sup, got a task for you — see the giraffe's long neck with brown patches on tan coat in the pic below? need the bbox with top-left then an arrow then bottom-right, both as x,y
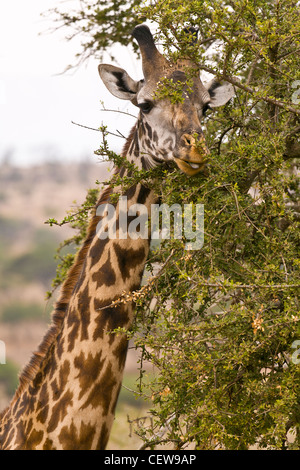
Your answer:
0,125 -> 156,450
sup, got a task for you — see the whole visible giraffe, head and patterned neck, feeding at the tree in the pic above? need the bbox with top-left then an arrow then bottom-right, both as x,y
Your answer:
0,24 -> 232,450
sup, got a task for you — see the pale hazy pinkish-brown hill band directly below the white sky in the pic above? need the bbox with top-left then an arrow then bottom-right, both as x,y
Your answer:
0,161 -> 109,227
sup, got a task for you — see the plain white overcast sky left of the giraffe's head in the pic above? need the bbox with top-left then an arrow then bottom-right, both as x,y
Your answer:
0,0 -> 142,166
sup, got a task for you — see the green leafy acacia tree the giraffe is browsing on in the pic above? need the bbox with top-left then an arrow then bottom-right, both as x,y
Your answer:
48,0 -> 300,449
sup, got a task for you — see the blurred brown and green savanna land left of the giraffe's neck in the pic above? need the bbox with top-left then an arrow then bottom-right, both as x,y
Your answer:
0,161 -> 110,402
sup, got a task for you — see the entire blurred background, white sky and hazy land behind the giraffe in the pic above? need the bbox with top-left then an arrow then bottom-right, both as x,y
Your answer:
0,0 -> 147,449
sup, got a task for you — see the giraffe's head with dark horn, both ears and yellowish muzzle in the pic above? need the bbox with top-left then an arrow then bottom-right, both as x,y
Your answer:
99,25 -> 234,175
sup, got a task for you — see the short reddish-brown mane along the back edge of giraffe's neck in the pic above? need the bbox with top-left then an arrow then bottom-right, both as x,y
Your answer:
0,126 -> 136,418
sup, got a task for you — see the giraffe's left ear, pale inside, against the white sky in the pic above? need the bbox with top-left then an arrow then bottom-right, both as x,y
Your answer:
98,64 -> 139,101
